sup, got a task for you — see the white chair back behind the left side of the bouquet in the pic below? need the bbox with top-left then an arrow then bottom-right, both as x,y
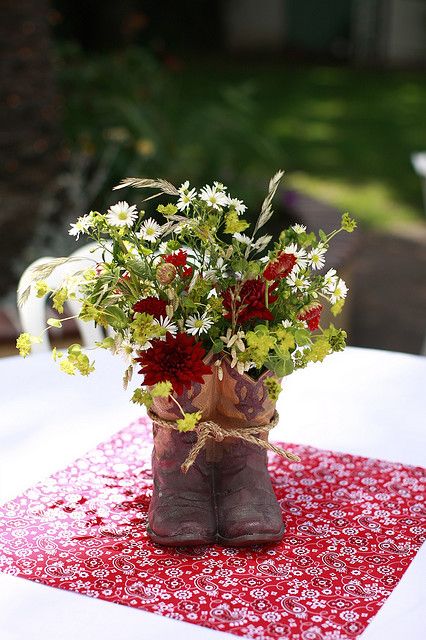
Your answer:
18,242 -> 112,353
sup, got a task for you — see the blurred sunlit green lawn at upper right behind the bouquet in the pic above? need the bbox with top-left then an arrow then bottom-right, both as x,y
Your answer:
177,63 -> 426,227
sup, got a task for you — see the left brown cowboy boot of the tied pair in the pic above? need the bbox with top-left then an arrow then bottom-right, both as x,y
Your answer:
147,376 -> 216,546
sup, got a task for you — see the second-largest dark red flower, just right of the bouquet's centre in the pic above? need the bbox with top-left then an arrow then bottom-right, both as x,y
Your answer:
223,278 -> 277,324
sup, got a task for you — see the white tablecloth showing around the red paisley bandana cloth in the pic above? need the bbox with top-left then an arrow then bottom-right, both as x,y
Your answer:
0,348 -> 426,640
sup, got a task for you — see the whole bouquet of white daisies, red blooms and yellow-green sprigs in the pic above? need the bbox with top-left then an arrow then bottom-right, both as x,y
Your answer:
17,171 -> 356,431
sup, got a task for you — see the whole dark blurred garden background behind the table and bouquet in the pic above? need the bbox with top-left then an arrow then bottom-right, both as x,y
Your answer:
0,0 -> 426,354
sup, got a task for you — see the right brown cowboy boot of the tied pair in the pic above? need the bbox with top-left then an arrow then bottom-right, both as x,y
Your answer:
214,360 -> 285,546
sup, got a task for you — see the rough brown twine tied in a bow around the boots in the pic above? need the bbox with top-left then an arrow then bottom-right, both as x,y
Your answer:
148,409 -> 300,473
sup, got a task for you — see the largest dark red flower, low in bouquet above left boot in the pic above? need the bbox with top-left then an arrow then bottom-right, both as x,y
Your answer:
136,332 -> 212,395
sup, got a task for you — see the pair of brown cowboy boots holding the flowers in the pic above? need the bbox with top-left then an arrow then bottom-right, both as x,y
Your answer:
148,361 -> 284,546
